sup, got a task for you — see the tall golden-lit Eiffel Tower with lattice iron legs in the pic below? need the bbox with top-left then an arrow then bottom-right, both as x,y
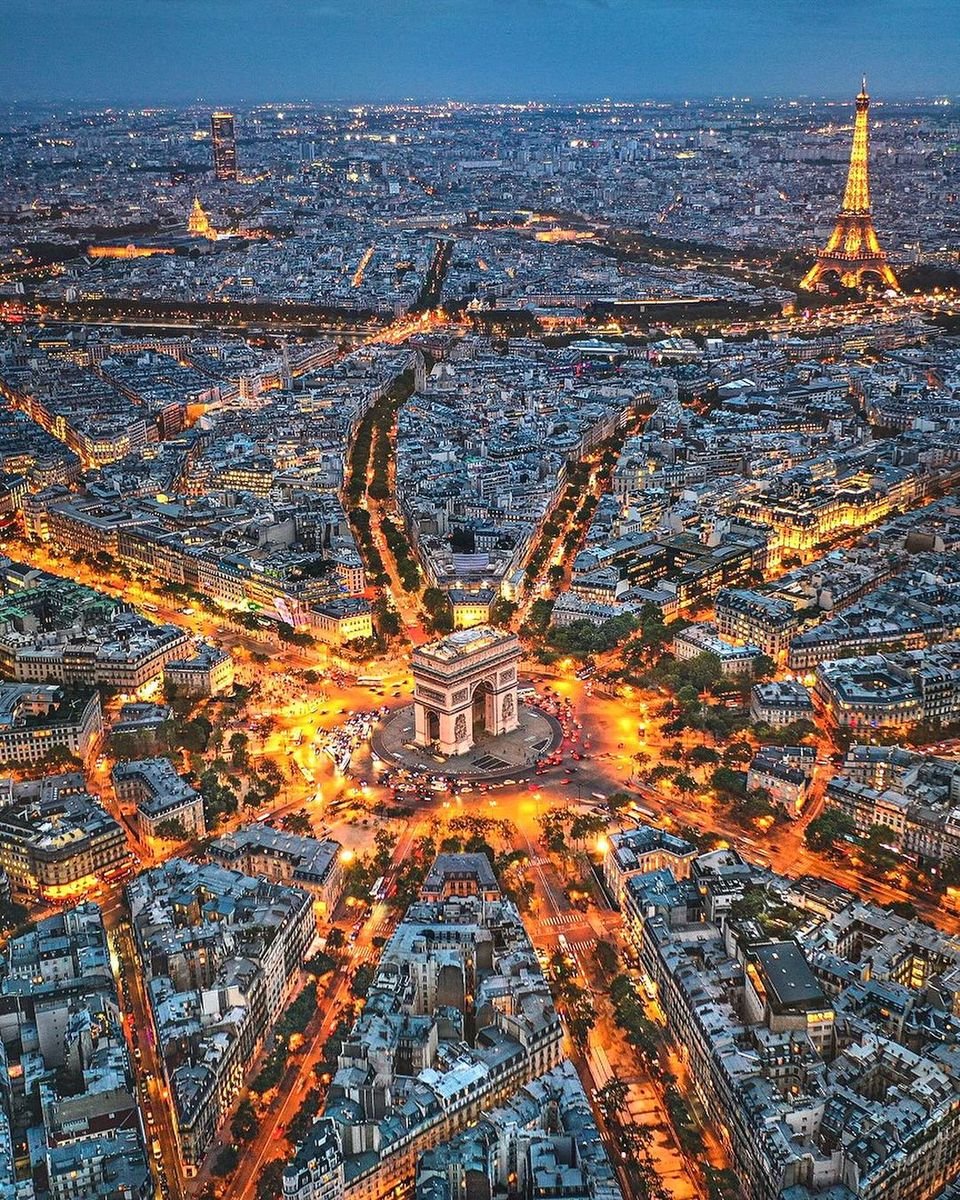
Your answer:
800,78 -> 900,292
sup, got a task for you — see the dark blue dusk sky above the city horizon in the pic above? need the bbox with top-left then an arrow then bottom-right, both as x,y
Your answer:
0,0 -> 960,103
